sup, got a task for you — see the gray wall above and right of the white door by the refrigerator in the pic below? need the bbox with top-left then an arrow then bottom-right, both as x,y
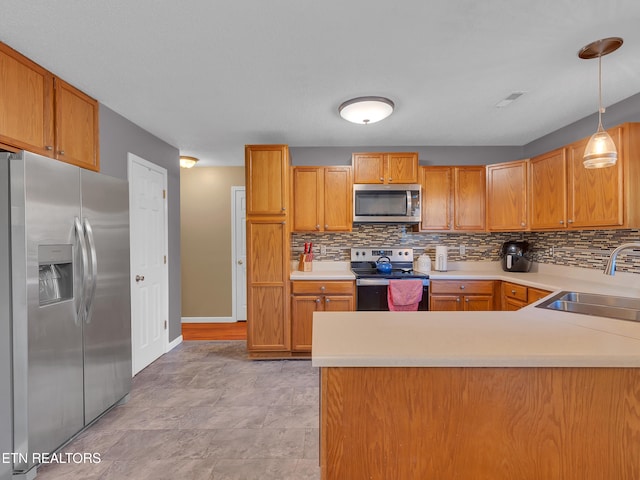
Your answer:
100,104 -> 182,341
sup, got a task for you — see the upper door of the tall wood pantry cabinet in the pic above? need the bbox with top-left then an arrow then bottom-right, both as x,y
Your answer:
245,145 -> 289,216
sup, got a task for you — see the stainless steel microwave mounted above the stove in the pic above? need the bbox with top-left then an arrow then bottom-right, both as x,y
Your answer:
353,184 -> 421,223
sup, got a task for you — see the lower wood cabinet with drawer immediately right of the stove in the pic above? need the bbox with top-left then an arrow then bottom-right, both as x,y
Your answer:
429,280 -> 500,312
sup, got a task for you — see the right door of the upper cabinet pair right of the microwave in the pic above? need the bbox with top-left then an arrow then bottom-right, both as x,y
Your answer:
453,167 -> 486,230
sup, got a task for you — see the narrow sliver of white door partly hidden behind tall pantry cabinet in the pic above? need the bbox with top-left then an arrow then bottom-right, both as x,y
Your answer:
231,187 -> 247,321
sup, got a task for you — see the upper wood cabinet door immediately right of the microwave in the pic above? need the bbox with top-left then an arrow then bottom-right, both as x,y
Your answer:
420,167 -> 452,230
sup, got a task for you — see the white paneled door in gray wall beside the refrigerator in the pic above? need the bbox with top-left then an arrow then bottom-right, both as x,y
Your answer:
129,153 -> 169,375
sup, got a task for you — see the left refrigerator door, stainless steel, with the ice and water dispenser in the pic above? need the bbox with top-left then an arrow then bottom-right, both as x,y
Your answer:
9,152 -> 84,471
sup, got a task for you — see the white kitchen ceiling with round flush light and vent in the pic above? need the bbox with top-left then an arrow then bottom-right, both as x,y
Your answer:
0,0 -> 640,166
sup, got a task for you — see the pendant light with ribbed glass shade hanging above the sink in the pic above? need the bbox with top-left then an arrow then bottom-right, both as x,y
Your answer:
578,37 -> 622,168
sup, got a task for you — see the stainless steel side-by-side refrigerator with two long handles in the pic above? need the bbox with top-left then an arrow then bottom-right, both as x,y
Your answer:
9,152 -> 131,478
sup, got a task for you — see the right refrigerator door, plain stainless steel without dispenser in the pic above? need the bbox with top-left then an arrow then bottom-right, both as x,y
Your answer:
81,170 -> 131,424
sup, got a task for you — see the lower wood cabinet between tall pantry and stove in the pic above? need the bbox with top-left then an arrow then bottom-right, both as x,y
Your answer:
291,280 -> 355,352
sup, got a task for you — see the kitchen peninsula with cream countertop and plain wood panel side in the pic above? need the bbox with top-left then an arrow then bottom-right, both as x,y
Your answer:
313,278 -> 640,480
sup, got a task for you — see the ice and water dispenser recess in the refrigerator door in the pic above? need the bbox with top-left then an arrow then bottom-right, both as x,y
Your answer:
38,245 -> 73,306
